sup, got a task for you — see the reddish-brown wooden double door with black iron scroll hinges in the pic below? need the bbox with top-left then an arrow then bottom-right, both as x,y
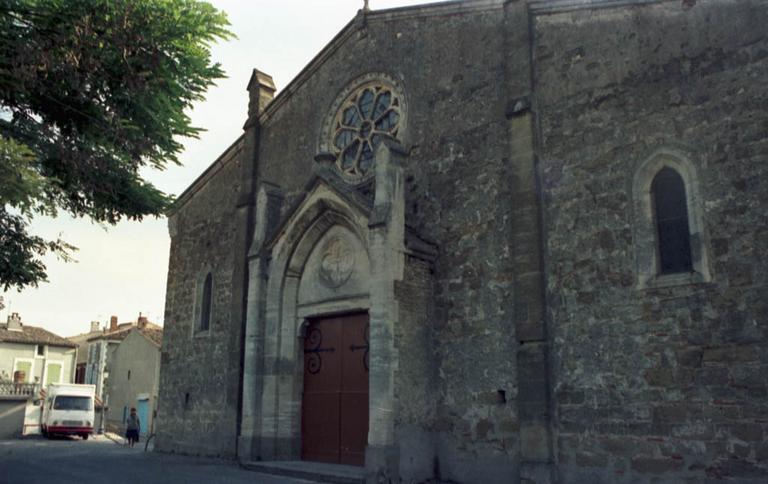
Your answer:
301,313 -> 369,466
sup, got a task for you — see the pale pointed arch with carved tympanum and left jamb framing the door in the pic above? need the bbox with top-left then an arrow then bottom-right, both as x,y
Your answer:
261,195 -> 371,459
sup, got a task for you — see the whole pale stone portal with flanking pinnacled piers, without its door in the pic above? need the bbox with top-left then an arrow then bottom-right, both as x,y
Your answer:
238,144 -> 433,478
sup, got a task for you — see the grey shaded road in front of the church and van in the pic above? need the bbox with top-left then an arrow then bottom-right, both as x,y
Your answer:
0,436 -> 316,484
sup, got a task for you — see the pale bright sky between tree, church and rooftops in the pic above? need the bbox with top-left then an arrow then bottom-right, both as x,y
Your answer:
0,0 -> 426,336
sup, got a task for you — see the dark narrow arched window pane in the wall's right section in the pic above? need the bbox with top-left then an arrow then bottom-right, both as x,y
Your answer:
651,167 -> 693,274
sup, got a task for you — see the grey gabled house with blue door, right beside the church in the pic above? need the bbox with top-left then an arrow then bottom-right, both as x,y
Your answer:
105,320 -> 163,434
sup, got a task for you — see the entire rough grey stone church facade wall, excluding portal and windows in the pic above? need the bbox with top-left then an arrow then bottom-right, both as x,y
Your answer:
158,0 -> 768,482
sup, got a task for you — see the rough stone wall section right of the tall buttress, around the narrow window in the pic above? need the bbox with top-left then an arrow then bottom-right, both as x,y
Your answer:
534,0 -> 768,483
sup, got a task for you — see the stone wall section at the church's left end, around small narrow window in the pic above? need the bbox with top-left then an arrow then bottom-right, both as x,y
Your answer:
157,143 -> 248,457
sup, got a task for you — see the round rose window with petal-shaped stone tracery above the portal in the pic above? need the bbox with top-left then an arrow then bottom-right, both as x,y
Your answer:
333,82 -> 402,178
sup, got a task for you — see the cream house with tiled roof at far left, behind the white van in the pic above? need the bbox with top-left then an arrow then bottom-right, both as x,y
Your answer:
0,313 -> 77,439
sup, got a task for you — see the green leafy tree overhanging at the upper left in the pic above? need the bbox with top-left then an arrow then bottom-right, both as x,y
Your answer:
0,0 -> 232,290
